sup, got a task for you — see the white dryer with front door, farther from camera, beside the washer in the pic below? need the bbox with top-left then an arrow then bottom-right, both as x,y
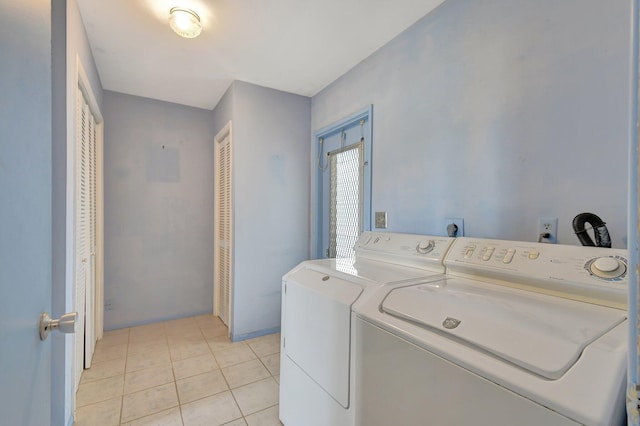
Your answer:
280,232 -> 453,426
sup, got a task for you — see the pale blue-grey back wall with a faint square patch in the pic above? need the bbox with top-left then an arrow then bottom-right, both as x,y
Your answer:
103,91 -> 214,330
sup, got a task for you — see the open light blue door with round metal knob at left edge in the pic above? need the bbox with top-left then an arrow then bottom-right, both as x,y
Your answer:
0,0 -> 52,425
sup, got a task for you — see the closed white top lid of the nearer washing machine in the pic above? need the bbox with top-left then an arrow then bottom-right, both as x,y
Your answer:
382,278 -> 626,379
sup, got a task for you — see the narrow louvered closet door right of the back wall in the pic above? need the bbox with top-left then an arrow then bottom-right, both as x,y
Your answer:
215,135 -> 233,326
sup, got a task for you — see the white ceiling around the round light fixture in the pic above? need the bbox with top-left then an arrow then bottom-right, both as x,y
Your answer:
78,0 -> 444,109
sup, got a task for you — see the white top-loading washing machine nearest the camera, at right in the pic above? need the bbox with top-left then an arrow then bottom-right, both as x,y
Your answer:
354,237 -> 627,426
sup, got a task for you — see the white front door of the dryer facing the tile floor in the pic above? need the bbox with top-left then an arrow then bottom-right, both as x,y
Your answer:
282,268 -> 362,408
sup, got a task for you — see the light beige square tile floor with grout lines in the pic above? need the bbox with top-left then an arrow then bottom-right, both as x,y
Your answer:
75,315 -> 281,426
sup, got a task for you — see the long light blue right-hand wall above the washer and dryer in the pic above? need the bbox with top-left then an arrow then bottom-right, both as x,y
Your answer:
312,0 -> 631,247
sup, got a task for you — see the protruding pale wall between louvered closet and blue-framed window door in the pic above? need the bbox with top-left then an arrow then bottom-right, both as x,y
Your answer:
213,81 -> 311,340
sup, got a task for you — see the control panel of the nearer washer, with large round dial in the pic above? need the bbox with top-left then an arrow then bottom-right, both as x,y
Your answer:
445,237 -> 628,308
